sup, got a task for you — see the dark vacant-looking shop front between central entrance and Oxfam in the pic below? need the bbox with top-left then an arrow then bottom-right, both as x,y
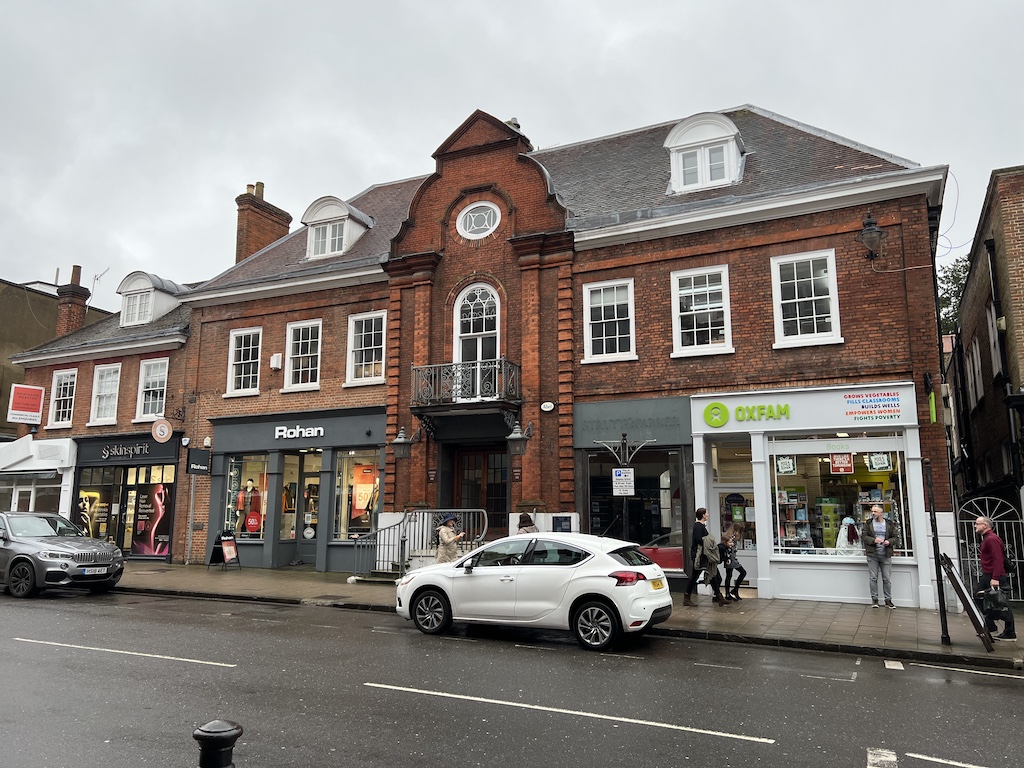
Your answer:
573,397 -> 693,558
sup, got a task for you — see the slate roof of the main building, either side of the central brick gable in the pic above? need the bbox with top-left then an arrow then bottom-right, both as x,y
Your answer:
179,104 -> 933,302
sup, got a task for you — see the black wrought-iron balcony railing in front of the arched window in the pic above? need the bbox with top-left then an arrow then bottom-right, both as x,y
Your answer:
412,357 -> 522,407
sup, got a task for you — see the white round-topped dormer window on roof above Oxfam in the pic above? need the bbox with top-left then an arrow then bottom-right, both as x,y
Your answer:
665,113 -> 743,195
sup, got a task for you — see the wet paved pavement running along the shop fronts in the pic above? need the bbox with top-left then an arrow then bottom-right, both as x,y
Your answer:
118,560 -> 1024,670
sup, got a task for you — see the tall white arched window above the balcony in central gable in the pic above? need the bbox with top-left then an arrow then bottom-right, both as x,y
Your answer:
454,284 -> 500,400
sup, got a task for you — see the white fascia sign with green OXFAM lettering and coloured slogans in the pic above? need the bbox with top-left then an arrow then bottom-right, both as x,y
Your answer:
690,382 -> 918,432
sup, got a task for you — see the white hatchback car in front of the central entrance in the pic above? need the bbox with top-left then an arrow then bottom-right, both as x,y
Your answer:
397,534 -> 672,650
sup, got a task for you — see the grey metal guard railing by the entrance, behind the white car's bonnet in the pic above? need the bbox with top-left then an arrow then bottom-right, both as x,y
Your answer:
352,509 -> 487,579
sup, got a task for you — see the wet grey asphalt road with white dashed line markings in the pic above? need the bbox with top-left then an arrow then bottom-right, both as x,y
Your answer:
0,592 -> 1024,768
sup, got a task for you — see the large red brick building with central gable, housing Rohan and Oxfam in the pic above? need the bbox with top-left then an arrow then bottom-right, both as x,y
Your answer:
8,105 -> 951,605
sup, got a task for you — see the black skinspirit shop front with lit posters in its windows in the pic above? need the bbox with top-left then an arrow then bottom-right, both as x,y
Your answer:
73,433 -> 181,559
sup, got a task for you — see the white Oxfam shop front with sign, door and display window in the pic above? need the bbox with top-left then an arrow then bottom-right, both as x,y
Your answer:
690,382 -> 952,608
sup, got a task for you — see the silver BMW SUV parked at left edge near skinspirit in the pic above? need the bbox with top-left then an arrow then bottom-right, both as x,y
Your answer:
0,512 -> 125,597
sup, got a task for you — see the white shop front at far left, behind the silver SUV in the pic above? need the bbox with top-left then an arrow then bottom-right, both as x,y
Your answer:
0,435 -> 78,522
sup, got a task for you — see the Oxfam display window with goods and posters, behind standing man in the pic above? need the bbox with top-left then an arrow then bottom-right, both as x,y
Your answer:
771,447 -> 913,557
